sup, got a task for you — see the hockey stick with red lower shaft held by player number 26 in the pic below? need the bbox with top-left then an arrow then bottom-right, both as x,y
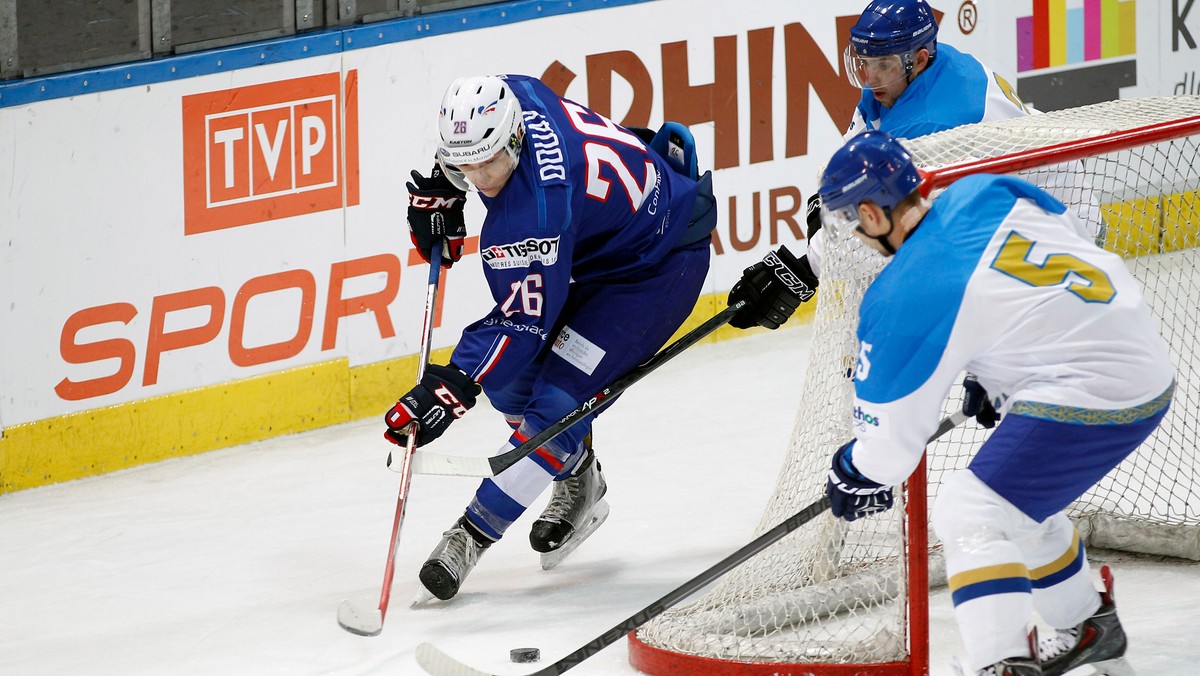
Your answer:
337,243 -> 442,636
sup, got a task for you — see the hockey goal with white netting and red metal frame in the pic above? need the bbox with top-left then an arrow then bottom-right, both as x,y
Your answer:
630,96 -> 1200,675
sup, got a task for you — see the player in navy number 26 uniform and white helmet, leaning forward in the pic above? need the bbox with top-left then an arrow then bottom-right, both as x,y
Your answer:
386,76 -> 715,599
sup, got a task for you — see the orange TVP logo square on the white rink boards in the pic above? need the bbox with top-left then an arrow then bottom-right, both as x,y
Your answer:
182,71 -> 359,234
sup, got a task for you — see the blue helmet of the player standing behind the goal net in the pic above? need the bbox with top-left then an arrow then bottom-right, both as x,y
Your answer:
850,0 -> 937,56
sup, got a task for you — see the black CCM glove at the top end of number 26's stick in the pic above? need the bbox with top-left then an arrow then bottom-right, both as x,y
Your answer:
406,163 -> 467,268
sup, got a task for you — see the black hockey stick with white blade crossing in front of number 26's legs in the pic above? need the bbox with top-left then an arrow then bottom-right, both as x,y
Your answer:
413,300 -> 746,477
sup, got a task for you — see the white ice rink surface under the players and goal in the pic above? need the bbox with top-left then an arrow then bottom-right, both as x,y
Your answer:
0,327 -> 1200,676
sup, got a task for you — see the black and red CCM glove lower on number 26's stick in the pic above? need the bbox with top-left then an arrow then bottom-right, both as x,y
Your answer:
383,364 -> 482,447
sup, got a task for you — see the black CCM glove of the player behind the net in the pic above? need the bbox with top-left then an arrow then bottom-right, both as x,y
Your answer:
730,246 -> 817,329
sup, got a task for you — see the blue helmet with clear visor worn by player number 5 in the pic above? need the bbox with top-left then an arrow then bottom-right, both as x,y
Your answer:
817,130 -> 920,239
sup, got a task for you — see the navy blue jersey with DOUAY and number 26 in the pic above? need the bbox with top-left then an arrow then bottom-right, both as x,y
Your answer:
451,76 -> 698,387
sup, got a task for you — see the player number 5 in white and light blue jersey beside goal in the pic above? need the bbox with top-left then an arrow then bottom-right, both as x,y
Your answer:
820,131 -> 1175,676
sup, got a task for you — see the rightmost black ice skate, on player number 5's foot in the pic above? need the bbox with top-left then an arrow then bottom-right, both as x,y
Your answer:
1038,566 -> 1134,676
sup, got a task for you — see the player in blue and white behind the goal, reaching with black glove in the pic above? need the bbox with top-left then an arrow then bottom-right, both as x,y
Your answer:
730,0 -> 1030,328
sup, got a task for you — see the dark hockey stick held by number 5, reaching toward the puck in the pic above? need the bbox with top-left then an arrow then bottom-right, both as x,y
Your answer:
416,411 -> 967,676
